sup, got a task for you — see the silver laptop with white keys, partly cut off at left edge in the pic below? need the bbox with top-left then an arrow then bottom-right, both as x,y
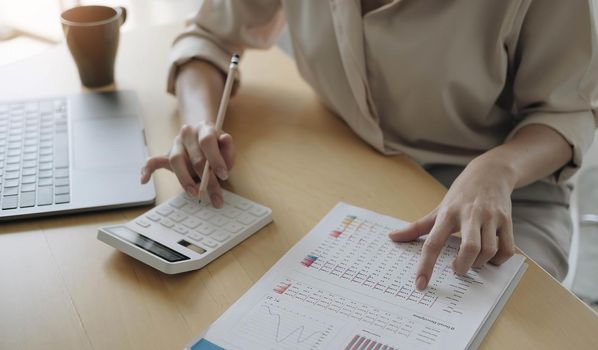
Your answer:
0,91 -> 156,220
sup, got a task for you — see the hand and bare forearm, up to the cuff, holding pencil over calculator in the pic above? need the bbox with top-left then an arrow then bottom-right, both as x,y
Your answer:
141,60 -> 235,208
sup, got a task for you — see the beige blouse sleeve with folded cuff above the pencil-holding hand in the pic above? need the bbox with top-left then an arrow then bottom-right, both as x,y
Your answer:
167,0 -> 285,94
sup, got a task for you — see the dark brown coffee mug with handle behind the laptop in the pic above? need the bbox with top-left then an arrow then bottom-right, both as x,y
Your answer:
60,6 -> 127,87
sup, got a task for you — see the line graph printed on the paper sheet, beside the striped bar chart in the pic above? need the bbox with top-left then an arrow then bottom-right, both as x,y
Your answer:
237,296 -> 334,350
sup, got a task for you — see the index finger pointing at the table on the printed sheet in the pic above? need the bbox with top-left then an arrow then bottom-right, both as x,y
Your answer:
415,216 -> 452,290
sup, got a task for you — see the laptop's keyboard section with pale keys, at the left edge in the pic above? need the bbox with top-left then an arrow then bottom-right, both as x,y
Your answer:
0,99 -> 70,210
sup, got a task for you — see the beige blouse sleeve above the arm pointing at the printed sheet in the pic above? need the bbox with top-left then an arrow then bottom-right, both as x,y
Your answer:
507,0 -> 598,183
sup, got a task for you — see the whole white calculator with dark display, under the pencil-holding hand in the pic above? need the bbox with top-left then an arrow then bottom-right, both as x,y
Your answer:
98,190 -> 272,274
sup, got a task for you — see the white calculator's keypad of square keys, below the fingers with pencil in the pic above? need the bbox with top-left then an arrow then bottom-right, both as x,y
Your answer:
134,191 -> 269,254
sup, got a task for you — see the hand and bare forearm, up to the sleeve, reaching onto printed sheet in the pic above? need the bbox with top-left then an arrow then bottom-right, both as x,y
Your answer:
390,124 -> 573,290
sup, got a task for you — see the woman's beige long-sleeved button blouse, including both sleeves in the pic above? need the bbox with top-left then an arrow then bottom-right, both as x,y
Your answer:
168,0 -> 598,181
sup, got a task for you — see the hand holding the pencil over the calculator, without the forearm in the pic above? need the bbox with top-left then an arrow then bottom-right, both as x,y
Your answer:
141,122 -> 235,208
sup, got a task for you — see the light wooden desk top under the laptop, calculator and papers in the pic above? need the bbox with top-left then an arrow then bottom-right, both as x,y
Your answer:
0,25 -> 598,350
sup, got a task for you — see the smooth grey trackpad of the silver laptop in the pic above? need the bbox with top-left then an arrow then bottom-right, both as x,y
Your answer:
71,116 -> 144,169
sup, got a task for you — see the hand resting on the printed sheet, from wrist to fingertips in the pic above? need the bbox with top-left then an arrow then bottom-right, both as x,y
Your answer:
390,156 -> 515,290
